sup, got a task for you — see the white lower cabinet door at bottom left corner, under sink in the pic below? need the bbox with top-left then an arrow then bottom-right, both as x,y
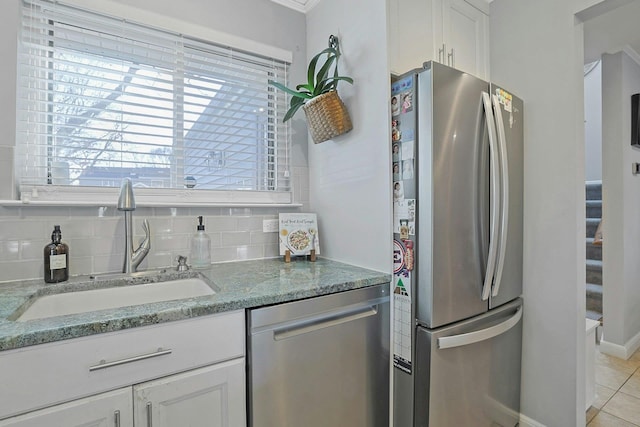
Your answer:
0,387 -> 133,427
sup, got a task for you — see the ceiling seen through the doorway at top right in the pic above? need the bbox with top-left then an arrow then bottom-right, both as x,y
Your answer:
584,0 -> 640,64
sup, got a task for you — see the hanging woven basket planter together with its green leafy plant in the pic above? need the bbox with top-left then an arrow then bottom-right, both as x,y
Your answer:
269,36 -> 353,144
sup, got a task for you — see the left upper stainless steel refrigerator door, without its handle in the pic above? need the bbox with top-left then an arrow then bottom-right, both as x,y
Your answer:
415,63 -> 490,328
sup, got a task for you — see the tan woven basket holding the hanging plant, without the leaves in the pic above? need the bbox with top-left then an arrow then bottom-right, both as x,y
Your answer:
302,90 -> 353,144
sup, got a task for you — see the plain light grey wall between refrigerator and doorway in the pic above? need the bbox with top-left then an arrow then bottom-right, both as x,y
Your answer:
490,0 -> 585,426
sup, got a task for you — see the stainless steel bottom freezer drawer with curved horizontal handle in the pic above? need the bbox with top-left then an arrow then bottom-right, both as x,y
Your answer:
414,299 -> 522,427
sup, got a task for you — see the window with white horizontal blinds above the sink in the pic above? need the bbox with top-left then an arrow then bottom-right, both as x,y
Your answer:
16,0 -> 290,204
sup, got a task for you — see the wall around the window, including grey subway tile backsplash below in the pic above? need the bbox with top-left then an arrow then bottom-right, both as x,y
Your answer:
0,0 -> 309,281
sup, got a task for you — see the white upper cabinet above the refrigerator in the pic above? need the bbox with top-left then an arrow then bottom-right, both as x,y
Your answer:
388,0 -> 489,79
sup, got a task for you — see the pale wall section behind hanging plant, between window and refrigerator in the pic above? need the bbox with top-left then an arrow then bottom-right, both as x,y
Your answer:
307,0 -> 392,272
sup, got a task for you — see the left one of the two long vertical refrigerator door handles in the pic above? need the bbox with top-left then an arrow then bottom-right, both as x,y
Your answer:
482,92 -> 500,301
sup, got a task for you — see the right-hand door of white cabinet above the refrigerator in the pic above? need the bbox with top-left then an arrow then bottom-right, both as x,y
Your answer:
441,0 -> 489,80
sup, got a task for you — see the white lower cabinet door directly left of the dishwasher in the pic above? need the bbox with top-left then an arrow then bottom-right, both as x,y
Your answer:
133,358 -> 246,427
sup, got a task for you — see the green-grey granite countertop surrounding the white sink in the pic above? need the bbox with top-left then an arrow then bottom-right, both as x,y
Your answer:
0,258 -> 391,351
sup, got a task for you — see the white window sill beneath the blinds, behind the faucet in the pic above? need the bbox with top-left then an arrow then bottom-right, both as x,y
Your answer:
0,185 -> 302,208
